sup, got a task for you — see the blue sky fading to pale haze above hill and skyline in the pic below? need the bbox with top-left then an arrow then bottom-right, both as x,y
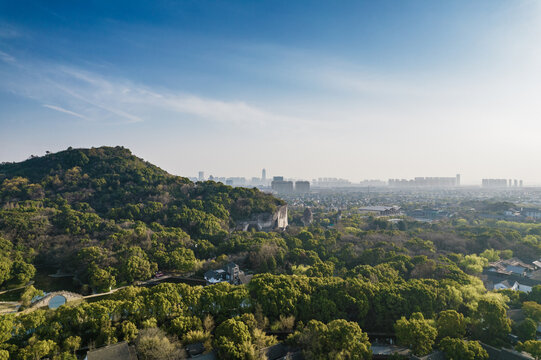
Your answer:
0,0 -> 541,185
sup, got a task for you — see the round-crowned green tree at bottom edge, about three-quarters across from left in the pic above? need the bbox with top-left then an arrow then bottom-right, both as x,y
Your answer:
394,313 -> 438,356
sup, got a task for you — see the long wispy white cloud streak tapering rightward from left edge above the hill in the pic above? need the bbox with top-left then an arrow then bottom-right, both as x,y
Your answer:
0,57 -> 300,125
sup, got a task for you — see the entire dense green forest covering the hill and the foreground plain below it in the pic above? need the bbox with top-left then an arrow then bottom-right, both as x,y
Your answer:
0,147 -> 541,359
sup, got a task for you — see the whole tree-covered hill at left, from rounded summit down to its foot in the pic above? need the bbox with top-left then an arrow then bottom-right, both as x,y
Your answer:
0,147 -> 283,288
